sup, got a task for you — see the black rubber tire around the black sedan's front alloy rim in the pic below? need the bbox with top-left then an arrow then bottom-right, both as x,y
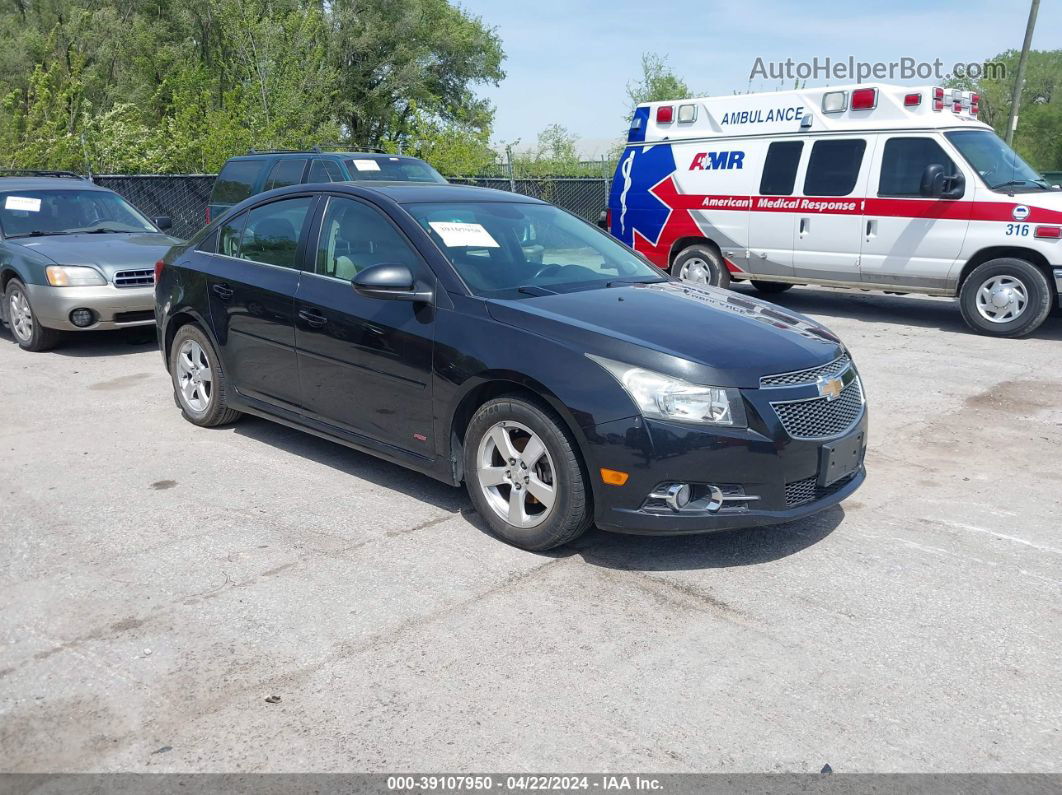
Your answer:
464,396 -> 594,552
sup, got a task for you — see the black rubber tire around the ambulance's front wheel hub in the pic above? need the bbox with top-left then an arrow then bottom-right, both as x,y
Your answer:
959,257 -> 1055,338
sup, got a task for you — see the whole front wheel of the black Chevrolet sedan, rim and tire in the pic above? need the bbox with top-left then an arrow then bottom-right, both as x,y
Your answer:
464,397 -> 592,551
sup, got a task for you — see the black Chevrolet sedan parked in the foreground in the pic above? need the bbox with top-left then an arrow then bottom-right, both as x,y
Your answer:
156,183 -> 867,550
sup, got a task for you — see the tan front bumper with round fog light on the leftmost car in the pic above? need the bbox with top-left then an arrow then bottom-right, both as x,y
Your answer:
25,284 -> 155,331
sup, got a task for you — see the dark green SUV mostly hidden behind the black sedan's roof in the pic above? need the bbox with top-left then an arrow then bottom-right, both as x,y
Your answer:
206,148 -> 446,224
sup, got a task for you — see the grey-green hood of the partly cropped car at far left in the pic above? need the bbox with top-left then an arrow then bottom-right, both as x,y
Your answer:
7,232 -> 181,278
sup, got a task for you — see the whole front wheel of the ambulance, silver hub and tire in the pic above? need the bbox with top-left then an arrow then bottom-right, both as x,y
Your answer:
959,257 -> 1052,338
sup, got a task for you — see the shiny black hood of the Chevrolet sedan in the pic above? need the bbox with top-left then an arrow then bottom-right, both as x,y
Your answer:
487,281 -> 844,388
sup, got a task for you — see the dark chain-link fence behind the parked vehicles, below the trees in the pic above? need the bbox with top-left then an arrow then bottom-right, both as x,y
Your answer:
93,174 -> 611,240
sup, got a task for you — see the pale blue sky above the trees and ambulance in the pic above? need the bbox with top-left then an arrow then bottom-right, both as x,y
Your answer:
458,0 -> 1062,158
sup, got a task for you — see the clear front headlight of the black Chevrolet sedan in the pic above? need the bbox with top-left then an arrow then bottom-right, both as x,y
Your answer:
586,353 -> 748,428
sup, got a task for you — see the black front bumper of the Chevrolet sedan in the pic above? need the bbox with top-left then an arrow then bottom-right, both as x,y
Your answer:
586,390 -> 868,535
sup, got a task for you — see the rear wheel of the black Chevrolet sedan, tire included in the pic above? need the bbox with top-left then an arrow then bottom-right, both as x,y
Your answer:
170,325 -> 240,428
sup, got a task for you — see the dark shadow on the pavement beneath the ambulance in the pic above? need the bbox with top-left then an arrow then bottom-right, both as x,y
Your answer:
732,282 -> 1062,340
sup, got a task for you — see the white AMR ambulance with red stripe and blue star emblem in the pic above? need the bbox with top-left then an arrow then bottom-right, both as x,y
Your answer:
605,84 -> 1062,336
